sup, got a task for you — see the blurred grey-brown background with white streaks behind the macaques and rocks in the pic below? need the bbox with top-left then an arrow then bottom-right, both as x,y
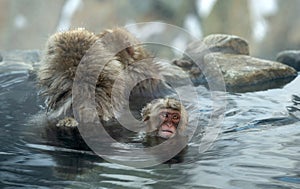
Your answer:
0,0 -> 300,59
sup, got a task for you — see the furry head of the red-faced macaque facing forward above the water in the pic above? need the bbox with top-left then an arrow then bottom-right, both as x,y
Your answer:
142,98 -> 188,139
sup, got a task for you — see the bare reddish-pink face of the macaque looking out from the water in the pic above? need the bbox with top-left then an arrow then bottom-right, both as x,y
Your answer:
158,109 -> 180,139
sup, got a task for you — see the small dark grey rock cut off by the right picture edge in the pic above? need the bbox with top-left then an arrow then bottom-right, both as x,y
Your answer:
276,50 -> 300,71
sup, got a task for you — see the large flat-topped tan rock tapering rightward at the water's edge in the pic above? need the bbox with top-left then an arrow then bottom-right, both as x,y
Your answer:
203,53 -> 297,92
